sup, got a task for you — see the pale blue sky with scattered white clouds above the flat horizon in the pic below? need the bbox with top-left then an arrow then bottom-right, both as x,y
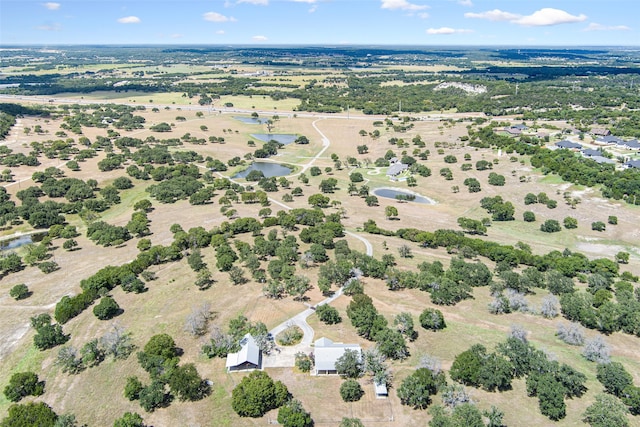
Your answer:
0,0 -> 640,46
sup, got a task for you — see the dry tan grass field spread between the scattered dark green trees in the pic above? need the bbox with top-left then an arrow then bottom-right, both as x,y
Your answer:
0,93 -> 640,427
